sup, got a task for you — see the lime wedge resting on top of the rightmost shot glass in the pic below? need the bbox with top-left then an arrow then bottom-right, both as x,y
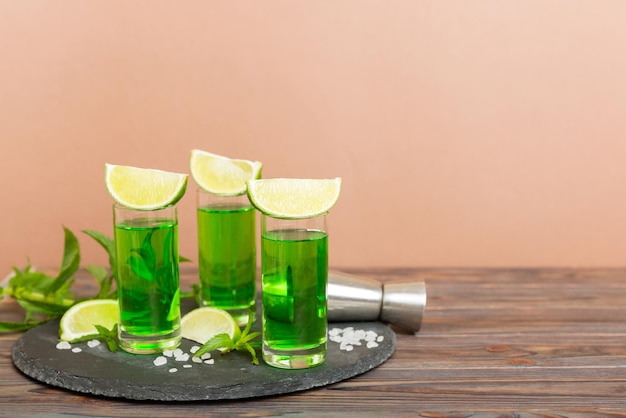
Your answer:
248,177 -> 341,219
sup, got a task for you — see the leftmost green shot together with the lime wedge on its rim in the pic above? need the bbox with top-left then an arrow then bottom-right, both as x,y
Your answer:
105,164 -> 187,354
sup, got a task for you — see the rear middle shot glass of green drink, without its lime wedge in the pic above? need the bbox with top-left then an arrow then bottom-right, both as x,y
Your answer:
197,189 -> 256,326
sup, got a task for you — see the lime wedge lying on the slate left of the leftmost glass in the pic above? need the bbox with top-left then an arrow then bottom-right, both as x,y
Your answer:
59,299 -> 120,341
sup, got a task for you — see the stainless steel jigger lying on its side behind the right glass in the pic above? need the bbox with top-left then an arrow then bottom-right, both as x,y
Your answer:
327,272 -> 426,333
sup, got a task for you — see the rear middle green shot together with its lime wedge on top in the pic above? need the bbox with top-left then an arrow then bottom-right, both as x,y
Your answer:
189,149 -> 263,326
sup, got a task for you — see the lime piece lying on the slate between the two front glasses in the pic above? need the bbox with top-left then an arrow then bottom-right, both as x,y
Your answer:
180,306 -> 241,344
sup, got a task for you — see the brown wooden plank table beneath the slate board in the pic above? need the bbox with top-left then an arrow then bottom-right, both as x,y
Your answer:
0,269 -> 626,417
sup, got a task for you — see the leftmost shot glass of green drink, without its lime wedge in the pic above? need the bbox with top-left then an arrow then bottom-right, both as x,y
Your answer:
113,204 -> 181,354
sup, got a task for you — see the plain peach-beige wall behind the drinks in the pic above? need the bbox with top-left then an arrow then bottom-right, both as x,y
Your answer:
0,0 -> 626,275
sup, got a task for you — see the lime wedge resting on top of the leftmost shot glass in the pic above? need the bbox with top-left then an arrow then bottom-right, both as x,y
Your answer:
105,164 -> 187,210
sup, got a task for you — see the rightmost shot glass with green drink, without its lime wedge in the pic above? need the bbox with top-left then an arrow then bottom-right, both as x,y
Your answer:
261,215 -> 328,369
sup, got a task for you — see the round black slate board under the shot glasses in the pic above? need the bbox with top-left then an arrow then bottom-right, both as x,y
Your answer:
12,321 -> 396,401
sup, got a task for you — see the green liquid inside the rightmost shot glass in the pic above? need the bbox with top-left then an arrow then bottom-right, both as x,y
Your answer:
262,230 -> 328,351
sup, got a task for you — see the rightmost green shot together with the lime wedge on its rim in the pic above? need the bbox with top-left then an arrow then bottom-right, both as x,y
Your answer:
248,178 -> 341,369
